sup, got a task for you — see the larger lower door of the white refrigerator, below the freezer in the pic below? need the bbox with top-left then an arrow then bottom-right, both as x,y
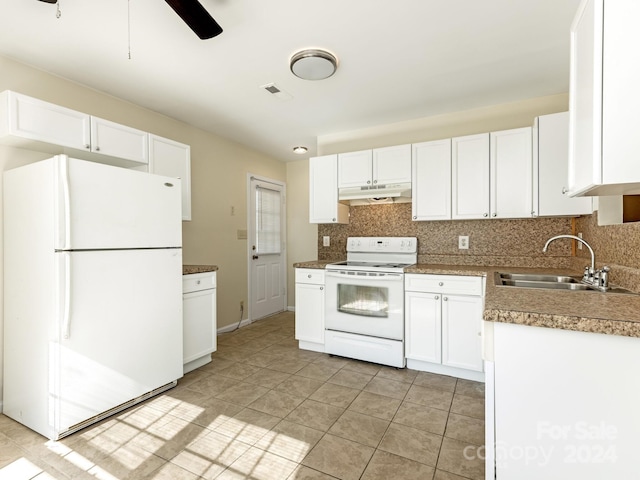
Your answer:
49,249 -> 182,437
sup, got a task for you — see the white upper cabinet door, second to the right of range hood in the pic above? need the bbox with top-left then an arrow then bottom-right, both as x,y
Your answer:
451,133 -> 489,220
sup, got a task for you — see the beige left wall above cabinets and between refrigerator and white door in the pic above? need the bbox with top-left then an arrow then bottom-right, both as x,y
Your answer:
0,57 -> 287,398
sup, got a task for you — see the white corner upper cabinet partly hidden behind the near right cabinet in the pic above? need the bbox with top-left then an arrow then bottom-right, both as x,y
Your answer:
533,112 -> 593,216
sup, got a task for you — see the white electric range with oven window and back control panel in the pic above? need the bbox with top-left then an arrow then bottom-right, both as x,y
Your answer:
325,237 -> 418,368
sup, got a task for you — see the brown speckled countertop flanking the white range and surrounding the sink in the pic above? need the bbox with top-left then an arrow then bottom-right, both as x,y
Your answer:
294,260 -> 640,337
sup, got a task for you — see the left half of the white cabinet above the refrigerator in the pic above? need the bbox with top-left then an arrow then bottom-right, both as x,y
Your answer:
0,90 -> 91,153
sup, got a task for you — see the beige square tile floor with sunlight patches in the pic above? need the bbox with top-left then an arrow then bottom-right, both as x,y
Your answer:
0,312 -> 484,480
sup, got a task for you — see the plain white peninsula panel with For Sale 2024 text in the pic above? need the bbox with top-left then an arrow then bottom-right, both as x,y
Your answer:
486,318 -> 640,480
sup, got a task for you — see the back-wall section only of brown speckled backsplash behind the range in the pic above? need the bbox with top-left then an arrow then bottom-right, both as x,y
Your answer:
318,203 -> 573,268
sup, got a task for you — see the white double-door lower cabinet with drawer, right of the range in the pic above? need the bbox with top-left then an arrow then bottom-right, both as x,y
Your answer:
405,274 -> 484,381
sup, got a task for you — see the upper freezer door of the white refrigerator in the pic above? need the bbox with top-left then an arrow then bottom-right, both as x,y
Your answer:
51,155 -> 182,250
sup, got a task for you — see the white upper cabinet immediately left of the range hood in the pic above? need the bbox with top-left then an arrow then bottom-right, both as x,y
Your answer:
309,155 -> 349,227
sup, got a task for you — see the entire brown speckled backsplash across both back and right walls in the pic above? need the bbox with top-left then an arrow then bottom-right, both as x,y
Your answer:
318,203 -> 640,292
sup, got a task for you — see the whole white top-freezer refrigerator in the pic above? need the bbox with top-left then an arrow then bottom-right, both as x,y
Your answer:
3,155 -> 182,440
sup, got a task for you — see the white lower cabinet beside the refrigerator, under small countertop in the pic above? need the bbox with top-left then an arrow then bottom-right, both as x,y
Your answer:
182,272 -> 217,373
